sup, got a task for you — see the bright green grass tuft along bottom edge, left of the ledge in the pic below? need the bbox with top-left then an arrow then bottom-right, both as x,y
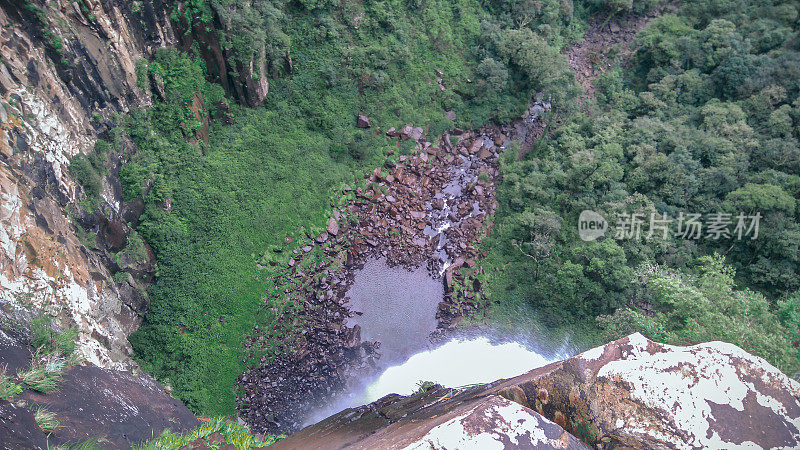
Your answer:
133,417 -> 285,450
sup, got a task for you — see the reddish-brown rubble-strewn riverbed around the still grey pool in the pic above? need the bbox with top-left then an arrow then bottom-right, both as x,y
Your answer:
237,121 -> 520,433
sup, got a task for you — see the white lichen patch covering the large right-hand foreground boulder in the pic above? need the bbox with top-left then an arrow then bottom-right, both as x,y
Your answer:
597,334 -> 800,448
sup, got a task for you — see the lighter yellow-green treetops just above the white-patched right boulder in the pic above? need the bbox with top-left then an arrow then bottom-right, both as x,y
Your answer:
598,255 -> 800,374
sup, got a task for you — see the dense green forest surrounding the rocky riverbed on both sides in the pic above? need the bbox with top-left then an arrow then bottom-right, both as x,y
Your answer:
72,0 -> 800,414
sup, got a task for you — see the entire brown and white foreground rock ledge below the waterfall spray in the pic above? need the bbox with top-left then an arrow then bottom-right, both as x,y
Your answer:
274,333 -> 800,449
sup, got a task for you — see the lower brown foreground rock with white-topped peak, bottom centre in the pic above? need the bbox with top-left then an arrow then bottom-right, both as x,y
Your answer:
270,386 -> 588,450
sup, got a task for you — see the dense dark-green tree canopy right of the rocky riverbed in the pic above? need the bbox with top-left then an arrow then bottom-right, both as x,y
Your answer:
484,0 -> 800,375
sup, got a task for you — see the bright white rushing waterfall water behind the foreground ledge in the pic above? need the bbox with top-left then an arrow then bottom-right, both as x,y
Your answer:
306,337 -> 568,425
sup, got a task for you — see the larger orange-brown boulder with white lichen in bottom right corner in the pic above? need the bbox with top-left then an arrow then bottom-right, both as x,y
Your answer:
492,333 -> 800,448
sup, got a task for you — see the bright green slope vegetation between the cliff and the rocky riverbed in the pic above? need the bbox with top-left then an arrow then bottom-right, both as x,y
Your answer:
125,0 -> 583,414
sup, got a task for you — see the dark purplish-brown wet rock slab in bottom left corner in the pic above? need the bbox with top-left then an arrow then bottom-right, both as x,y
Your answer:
0,334 -> 197,449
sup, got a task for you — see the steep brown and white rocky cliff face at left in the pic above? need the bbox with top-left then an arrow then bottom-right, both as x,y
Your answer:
0,0 -> 268,368
